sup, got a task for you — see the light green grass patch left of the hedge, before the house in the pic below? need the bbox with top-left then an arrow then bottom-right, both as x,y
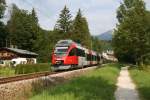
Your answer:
0,67 -> 15,77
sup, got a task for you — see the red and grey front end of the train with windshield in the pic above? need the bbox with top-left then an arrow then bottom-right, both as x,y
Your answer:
52,40 -> 76,71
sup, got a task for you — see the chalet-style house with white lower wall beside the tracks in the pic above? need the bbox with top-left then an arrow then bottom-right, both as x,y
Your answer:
0,48 -> 38,66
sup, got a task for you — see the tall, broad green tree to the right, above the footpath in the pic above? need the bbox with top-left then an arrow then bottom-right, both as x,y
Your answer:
113,0 -> 150,64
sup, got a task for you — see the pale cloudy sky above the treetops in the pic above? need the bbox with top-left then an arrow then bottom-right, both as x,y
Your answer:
6,0 -> 150,35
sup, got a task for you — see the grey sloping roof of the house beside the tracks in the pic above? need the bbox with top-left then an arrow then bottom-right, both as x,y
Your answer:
0,48 -> 38,56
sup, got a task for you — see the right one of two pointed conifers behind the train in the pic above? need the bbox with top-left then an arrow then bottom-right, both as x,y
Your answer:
72,9 -> 91,48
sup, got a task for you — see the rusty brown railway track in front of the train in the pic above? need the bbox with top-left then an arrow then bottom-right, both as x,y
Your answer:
0,72 -> 56,85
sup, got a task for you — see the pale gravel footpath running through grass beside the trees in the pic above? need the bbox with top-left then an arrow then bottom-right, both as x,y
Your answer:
115,67 -> 139,100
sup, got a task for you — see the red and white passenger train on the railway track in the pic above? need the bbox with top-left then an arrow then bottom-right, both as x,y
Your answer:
52,40 -> 102,71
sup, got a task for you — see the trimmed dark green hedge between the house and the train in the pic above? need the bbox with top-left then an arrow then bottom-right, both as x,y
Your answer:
15,63 -> 51,74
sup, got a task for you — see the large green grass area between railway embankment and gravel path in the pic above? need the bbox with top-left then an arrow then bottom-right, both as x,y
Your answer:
30,64 -> 120,100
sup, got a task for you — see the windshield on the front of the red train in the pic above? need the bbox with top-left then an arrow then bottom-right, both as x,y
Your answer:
54,47 -> 68,56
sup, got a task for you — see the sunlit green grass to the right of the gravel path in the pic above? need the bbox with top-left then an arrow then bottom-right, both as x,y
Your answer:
130,68 -> 150,100
